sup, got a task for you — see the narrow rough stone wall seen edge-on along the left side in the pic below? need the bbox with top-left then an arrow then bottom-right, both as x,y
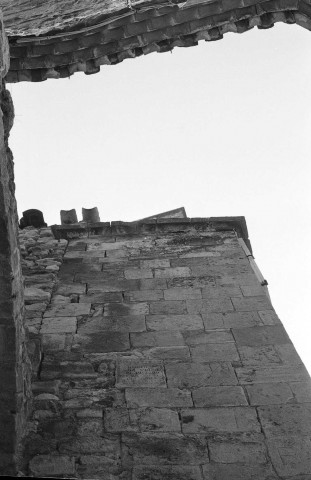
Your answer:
0,10 -> 30,475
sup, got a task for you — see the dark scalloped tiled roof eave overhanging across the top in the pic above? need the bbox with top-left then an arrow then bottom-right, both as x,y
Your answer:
3,0 -> 311,83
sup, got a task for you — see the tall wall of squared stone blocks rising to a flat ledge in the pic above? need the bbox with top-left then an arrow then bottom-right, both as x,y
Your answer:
23,219 -> 311,480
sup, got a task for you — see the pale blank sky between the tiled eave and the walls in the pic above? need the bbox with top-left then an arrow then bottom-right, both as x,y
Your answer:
8,24 -> 311,373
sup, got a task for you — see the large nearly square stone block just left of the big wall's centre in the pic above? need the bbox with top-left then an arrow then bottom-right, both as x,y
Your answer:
116,358 -> 166,388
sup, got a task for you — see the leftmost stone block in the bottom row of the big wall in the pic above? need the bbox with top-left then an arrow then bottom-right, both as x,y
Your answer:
29,455 -> 76,477
